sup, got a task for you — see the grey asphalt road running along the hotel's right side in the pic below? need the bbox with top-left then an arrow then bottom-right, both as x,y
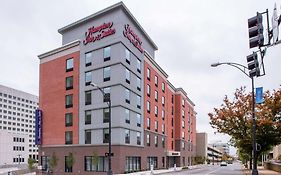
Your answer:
163,163 -> 244,175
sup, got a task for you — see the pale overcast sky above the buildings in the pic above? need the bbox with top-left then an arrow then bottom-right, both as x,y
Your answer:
0,0 -> 281,154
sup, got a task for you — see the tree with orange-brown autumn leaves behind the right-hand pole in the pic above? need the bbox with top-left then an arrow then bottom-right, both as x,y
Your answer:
208,87 -> 281,161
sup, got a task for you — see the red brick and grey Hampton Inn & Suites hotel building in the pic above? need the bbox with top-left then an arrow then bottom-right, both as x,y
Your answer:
38,2 -> 196,174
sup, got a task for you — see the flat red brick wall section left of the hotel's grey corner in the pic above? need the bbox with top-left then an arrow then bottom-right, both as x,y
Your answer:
39,52 -> 80,145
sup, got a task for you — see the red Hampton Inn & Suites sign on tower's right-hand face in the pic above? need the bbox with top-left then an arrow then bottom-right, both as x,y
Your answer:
123,24 -> 144,53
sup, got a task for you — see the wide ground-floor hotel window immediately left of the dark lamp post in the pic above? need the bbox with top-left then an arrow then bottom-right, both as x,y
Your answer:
84,156 -> 108,172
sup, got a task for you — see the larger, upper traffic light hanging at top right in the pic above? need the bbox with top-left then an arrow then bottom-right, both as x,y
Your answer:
248,13 -> 264,48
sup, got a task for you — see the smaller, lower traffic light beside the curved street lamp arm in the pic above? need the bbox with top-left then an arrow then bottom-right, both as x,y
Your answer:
247,52 -> 260,77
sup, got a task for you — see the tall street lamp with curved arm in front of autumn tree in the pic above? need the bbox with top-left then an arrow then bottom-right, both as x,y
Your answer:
211,62 -> 259,175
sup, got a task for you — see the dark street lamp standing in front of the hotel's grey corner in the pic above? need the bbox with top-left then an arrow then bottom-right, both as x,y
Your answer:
90,83 -> 112,175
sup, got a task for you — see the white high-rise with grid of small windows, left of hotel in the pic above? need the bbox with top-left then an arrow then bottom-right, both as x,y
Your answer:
0,85 -> 38,166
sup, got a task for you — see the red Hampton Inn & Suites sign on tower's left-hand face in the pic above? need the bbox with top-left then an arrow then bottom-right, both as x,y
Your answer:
83,22 -> 116,45
